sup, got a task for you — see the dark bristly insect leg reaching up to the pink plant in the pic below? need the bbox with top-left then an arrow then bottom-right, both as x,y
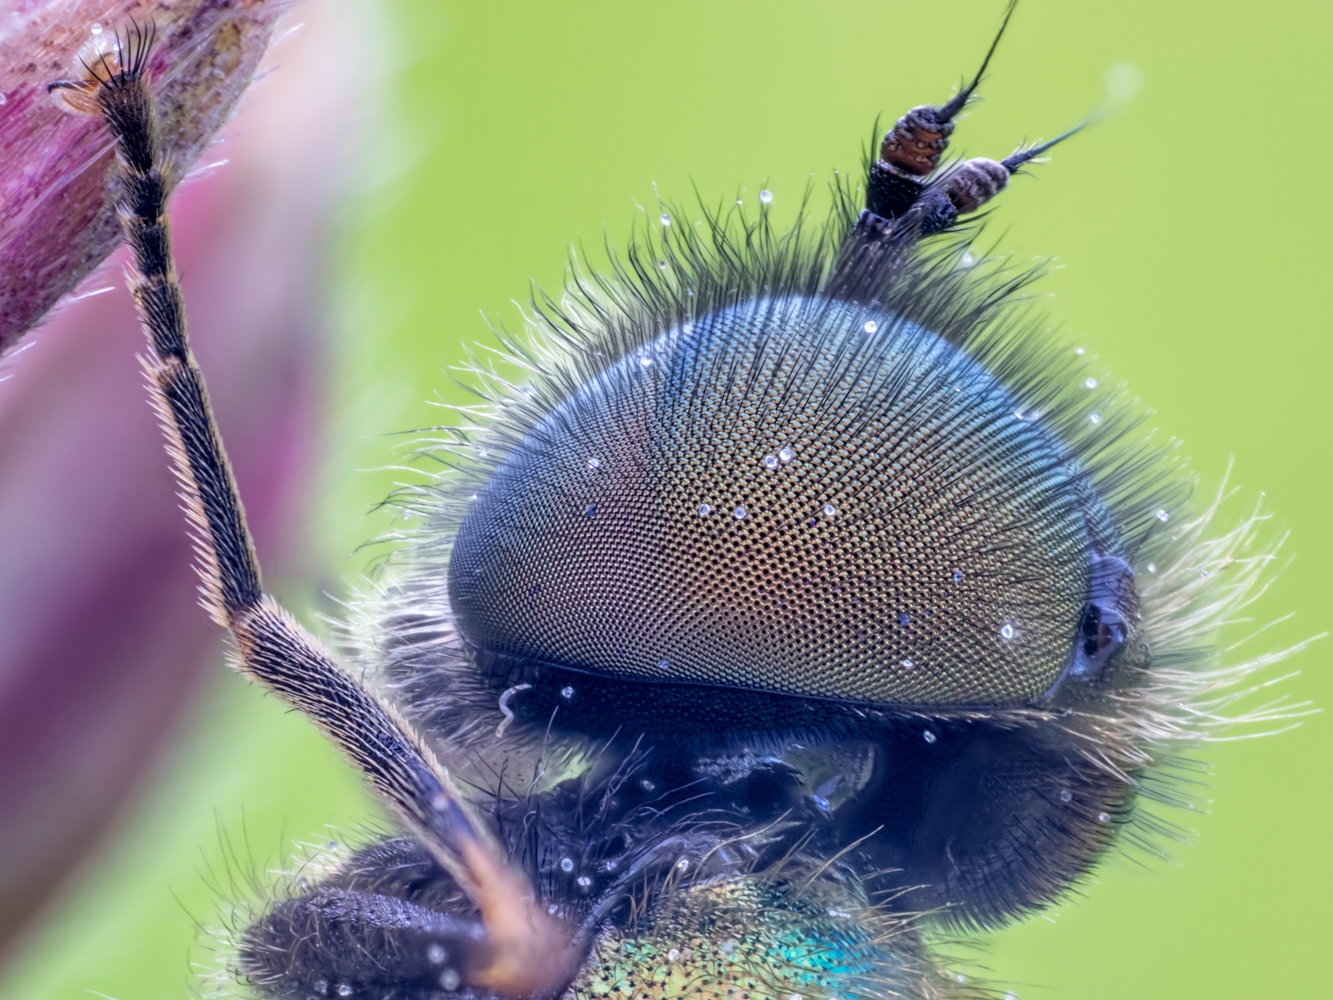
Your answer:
52,24 -> 573,996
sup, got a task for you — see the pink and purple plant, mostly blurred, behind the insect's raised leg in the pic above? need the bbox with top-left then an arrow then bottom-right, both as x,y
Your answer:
0,0 -> 364,948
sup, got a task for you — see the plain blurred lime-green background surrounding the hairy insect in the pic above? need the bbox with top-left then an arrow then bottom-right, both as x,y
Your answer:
0,0 -> 1333,1000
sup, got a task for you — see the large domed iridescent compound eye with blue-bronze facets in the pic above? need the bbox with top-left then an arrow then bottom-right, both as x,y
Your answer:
449,296 -> 1125,705
